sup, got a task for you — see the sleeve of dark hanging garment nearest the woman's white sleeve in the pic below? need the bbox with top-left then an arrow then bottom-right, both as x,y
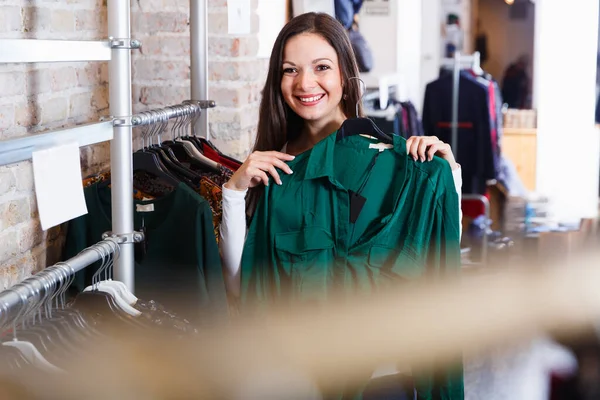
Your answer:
196,202 -> 228,318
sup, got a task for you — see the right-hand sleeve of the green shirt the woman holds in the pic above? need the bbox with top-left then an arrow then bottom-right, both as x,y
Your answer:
413,169 -> 464,400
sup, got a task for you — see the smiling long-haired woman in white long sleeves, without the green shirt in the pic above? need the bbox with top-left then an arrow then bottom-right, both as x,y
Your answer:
220,13 -> 462,298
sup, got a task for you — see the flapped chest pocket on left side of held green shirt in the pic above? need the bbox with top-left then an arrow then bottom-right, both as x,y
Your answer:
275,227 -> 335,297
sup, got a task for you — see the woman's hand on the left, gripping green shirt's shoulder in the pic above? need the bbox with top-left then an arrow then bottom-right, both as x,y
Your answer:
225,151 -> 294,191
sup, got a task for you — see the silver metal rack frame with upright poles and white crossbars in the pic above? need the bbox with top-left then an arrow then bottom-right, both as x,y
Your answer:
0,0 -> 214,293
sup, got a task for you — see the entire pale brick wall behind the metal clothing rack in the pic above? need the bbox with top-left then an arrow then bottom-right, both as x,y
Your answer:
0,0 -> 267,289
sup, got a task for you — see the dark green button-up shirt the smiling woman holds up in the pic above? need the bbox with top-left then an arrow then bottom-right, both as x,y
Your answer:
241,134 -> 463,399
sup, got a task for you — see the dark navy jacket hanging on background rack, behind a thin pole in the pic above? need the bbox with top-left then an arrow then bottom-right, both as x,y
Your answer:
423,71 -> 496,194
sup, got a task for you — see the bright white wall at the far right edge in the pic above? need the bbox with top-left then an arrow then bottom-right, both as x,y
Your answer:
534,0 -> 600,219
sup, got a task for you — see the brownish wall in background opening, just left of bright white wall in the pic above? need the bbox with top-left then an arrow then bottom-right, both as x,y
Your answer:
478,0 -> 535,85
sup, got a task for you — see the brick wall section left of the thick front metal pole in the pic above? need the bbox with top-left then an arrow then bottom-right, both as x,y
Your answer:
0,0 -> 108,289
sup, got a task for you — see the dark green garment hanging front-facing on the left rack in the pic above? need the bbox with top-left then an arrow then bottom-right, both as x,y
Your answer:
63,183 -> 227,323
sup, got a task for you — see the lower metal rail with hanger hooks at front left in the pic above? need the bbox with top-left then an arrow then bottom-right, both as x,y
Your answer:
0,238 -> 119,325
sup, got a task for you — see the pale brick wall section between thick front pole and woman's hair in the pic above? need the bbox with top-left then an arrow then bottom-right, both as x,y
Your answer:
132,0 -> 268,160
